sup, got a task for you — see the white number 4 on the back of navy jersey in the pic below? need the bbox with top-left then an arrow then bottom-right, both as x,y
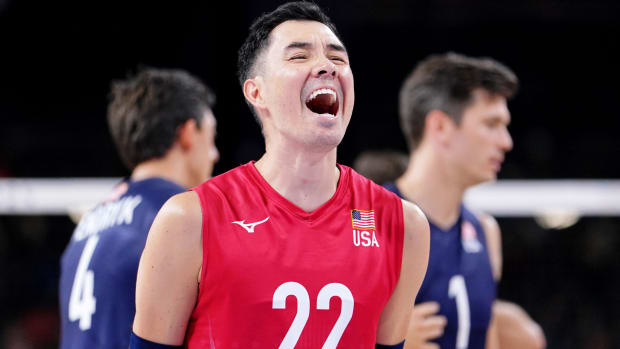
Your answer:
69,235 -> 99,331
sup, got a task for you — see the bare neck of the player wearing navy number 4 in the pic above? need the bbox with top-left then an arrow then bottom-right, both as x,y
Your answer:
131,149 -> 194,188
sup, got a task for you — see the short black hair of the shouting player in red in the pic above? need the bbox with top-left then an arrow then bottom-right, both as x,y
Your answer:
237,1 -> 342,123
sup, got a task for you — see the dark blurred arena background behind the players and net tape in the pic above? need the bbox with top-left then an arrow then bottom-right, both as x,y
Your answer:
0,0 -> 620,349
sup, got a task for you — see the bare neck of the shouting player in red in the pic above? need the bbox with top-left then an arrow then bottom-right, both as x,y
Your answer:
256,139 -> 340,212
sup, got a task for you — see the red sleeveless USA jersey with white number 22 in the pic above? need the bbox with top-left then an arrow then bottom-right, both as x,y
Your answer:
185,163 -> 404,349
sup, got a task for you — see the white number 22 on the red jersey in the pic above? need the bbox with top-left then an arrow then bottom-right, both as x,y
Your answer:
272,281 -> 355,349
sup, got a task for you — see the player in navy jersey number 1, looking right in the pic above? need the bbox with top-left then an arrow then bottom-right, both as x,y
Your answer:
386,53 -> 545,349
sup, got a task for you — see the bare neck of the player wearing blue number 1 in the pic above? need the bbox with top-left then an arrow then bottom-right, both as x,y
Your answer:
396,145 -> 467,229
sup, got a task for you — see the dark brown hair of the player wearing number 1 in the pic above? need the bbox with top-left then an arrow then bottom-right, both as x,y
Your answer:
400,52 -> 519,151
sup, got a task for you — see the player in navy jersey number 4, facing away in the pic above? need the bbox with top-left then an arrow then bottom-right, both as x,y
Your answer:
59,69 -> 219,349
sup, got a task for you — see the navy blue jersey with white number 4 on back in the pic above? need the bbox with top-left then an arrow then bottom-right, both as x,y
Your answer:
59,178 -> 184,349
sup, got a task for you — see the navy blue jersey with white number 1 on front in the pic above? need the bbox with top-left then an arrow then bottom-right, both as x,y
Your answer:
385,183 -> 496,349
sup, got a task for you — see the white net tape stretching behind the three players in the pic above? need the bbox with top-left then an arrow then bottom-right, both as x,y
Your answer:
0,178 -> 620,217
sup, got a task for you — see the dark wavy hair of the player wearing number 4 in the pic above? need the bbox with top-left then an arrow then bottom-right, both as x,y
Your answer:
108,68 -> 215,170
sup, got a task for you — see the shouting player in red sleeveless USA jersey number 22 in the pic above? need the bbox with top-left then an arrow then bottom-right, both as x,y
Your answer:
132,2 -> 429,349
